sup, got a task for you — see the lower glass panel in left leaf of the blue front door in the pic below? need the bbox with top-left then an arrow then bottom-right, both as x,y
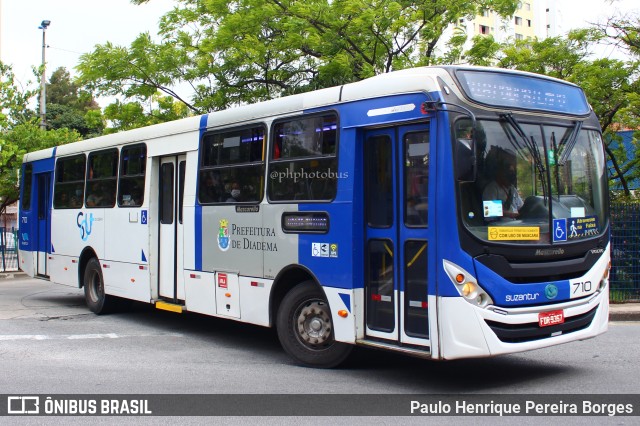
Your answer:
366,240 -> 395,332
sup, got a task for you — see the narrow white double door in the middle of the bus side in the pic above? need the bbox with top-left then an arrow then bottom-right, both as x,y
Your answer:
158,155 -> 186,302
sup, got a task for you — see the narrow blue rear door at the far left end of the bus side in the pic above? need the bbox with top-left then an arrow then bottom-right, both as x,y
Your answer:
35,172 -> 51,277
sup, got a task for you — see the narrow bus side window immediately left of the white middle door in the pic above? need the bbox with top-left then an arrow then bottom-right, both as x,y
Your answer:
118,144 -> 147,207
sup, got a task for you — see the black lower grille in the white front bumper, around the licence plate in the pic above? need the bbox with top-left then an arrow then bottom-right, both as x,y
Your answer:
485,307 -> 598,343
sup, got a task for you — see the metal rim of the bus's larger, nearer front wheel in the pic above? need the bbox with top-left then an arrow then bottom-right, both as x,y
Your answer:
294,300 -> 333,350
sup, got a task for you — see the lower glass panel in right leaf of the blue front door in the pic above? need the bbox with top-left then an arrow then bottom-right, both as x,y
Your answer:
404,241 -> 429,338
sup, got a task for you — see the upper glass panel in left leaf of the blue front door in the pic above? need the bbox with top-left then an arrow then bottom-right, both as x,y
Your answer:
365,135 -> 394,228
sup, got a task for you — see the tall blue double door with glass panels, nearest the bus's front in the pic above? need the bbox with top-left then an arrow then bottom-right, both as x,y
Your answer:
363,124 -> 430,351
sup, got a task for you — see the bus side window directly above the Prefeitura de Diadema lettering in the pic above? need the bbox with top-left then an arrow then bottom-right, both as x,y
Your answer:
198,126 -> 265,204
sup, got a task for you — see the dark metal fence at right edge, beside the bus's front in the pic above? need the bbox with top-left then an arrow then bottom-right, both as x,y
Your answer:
610,203 -> 640,302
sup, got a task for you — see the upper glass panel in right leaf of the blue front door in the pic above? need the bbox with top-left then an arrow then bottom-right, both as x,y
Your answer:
404,132 -> 429,228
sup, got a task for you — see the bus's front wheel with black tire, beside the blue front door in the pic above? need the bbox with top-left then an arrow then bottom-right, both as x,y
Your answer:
276,281 -> 353,368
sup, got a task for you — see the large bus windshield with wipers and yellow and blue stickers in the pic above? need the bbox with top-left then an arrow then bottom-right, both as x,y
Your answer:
455,118 -> 607,244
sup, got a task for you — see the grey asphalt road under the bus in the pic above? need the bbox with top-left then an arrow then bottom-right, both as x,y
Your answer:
0,278 -> 640,424
